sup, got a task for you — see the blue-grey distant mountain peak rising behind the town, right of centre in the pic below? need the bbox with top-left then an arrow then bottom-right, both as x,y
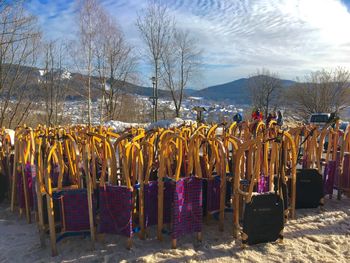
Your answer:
192,77 -> 295,104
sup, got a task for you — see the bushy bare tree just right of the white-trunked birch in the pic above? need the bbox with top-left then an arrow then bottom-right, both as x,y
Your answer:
96,10 -> 137,122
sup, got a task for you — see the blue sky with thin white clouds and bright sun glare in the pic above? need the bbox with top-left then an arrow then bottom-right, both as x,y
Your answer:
26,0 -> 350,89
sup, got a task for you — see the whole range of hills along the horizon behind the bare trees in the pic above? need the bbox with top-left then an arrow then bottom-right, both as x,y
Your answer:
0,64 -> 295,104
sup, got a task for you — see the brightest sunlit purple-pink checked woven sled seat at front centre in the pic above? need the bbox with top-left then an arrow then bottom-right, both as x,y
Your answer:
172,177 -> 203,238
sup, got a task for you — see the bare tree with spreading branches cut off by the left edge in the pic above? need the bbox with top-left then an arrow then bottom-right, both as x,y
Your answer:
0,1 -> 40,127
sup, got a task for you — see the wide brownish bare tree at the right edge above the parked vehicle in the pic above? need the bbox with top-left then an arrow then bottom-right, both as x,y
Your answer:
286,68 -> 350,120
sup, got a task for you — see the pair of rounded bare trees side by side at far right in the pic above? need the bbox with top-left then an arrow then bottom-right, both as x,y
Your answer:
248,67 -> 350,122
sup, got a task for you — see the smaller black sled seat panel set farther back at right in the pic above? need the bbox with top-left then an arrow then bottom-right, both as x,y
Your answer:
295,169 -> 324,208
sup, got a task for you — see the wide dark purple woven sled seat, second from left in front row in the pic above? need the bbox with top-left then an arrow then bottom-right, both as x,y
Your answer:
99,185 -> 132,237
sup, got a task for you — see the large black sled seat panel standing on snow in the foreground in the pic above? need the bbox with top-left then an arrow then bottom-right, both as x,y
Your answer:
242,192 -> 284,245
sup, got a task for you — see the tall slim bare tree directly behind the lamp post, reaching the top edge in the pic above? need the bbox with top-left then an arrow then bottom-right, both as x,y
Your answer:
136,0 -> 174,121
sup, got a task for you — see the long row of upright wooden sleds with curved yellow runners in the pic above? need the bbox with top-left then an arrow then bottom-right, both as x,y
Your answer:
0,121 -> 350,255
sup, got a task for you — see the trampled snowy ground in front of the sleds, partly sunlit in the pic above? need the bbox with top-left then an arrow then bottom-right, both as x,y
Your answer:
0,199 -> 350,263
